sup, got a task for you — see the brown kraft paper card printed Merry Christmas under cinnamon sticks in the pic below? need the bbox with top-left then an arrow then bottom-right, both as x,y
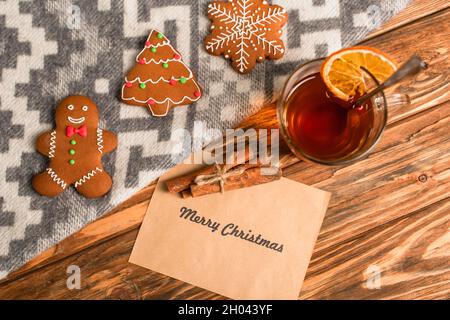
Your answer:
130,164 -> 330,299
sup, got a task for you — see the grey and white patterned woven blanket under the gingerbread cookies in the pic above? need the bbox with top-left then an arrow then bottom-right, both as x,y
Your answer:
0,0 -> 409,278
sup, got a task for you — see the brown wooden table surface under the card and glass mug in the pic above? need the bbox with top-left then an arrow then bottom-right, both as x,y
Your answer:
0,0 -> 450,299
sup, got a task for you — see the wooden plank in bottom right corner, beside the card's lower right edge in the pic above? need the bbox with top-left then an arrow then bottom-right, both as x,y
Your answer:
300,198 -> 450,299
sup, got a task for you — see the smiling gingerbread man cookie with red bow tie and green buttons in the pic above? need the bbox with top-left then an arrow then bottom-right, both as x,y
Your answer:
32,96 -> 117,198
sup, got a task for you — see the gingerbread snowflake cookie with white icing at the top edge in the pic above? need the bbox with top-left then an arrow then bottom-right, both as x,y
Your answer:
205,0 -> 288,73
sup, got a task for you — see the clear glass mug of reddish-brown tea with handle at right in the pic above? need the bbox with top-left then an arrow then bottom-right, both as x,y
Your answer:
277,59 -> 410,166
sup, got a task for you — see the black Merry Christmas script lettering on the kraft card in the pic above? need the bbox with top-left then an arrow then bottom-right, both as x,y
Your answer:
180,207 -> 283,252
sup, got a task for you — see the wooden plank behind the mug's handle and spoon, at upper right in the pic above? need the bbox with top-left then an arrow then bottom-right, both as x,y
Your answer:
361,9 -> 450,123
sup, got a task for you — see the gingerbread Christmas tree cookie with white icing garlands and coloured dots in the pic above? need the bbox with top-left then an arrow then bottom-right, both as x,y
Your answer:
121,30 -> 202,117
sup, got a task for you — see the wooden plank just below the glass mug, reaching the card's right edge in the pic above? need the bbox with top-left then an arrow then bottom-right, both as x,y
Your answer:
285,103 -> 450,254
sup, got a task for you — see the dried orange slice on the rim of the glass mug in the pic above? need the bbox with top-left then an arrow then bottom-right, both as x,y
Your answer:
320,46 -> 397,101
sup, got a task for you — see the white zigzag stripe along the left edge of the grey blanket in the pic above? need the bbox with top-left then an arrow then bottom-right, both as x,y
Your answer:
0,0 -> 57,256
